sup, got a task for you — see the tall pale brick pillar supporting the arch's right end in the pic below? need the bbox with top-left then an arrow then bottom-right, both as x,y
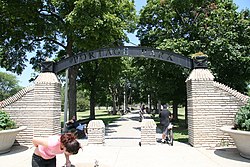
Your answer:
186,69 -> 216,147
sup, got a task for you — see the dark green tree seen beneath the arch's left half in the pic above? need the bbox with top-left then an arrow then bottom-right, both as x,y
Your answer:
78,58 -> 123,119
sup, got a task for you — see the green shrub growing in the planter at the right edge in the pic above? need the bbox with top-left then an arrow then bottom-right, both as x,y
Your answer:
234,100 -> 250,131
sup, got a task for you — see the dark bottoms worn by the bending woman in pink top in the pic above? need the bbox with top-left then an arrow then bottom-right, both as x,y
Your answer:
32,154 -> 56,167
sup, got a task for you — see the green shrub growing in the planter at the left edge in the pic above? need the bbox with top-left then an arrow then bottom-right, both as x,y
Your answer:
0,110 -> 16,131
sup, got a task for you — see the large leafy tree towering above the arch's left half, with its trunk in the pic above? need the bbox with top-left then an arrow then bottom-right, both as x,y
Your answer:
0,0 -> 136,117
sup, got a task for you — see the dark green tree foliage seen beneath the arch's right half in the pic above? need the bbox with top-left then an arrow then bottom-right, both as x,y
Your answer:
133,56 -> 188,119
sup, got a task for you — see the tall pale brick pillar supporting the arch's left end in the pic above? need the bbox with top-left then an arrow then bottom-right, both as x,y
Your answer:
30,72 -> 61,137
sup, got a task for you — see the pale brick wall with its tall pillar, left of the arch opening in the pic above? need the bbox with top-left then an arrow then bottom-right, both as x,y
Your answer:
0,73 -> 61,145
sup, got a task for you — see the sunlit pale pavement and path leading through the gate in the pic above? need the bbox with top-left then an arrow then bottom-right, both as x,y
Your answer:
0,112 -> 250,167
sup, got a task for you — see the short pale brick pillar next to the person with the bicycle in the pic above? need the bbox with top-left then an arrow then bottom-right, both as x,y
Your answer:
141,119 -> 156,145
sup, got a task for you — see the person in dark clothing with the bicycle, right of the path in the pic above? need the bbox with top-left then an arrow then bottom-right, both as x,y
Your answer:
159,105 -> 172,143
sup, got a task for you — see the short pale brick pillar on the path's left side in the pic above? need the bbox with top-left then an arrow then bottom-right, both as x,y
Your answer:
88,120 -> 105,144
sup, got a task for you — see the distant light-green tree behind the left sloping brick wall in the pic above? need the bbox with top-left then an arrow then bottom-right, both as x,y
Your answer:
0,72 -> 22,101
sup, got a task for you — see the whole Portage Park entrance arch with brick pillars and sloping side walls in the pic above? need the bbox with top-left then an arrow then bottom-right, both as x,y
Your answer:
8,46 -> 250,147
